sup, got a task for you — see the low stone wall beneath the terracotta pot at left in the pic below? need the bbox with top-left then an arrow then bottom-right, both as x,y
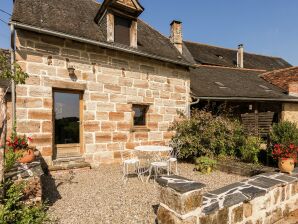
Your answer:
5,161 -> 44,203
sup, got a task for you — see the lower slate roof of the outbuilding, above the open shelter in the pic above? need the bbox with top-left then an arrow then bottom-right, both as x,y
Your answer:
190,66 -> 298,100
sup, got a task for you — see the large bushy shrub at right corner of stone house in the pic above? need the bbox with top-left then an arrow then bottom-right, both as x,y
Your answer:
170,110 -> 243,159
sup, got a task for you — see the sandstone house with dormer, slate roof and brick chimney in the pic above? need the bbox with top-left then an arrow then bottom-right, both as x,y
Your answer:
11,0 -> 191,166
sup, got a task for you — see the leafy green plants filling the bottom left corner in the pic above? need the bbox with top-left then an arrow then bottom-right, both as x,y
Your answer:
0,183 -> 47,224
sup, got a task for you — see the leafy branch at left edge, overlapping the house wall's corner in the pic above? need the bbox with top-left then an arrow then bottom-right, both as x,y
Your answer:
0,54 -> 29,84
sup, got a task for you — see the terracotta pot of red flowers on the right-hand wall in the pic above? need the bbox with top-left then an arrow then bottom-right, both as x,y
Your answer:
272,144 -> 298,174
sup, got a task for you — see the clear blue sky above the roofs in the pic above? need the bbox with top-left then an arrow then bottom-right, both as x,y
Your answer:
0,0 -> 298,65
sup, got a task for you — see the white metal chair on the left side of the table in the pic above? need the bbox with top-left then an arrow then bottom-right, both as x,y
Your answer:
120,150 -> 143,183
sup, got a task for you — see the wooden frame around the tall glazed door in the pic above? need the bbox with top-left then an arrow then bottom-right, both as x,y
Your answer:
52,88 -> 85,160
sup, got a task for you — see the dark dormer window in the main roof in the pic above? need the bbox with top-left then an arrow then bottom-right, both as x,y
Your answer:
114,16 -> 131,45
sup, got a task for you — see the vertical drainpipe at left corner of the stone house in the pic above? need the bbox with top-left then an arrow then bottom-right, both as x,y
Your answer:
10,23 -> 16,131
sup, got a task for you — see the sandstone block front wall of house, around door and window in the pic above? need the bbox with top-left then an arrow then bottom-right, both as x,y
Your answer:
16,30 -> 190,166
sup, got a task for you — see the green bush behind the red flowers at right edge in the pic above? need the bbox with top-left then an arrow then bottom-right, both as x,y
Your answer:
270,121 -> 298,147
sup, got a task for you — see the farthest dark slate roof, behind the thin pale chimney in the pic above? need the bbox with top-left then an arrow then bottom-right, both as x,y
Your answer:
184,41 -> 292,71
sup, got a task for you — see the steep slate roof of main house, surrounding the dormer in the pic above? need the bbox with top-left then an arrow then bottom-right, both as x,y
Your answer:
12,0 -> 191,64
